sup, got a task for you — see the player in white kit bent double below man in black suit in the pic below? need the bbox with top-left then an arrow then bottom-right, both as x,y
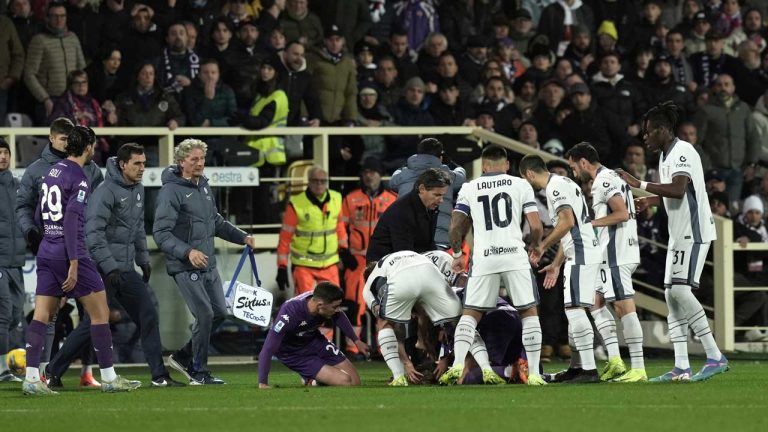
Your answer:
363,251 -> 460,387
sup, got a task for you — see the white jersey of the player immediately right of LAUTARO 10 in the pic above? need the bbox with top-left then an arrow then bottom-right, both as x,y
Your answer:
546,174 -> 603,265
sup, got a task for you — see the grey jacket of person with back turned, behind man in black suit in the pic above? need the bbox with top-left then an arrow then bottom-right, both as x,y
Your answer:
389,154 -> 467,245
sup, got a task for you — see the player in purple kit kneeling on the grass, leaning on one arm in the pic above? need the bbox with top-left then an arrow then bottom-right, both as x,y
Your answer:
259,282 -> 369,389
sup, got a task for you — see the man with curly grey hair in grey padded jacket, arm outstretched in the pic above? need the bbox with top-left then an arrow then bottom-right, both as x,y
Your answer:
152,138 -> 256,385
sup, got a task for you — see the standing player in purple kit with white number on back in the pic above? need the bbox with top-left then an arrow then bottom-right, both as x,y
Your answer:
22,126 -> 141,395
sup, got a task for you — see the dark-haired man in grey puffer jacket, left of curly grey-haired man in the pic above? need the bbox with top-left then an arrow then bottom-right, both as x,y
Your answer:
86,143 -> 183,387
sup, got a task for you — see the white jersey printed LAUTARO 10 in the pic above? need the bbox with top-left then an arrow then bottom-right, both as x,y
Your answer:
454,173 -> 538,276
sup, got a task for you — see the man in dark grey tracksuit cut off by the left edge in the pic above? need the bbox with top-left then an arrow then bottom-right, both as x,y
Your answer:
0,139 -> 27,382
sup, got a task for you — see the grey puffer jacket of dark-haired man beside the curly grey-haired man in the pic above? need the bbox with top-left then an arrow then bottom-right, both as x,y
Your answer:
85,157 -> 149,275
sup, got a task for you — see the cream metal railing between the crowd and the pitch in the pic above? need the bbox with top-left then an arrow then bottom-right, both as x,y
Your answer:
0,126 -> 768,351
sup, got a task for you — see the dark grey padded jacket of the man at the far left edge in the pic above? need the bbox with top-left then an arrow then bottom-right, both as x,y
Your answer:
0,170 -> 27,267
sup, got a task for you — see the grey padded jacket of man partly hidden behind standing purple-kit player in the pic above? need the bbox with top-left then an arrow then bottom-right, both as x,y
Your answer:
16,144 -> 104,237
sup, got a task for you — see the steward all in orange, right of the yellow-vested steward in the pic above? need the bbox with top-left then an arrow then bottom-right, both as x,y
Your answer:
340,158 -> 397,326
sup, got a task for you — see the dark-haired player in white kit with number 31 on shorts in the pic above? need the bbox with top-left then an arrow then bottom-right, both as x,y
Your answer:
617,102 -> 729,381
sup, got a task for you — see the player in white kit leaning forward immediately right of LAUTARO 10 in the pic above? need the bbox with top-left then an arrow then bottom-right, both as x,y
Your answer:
520,155 -> 603,383
